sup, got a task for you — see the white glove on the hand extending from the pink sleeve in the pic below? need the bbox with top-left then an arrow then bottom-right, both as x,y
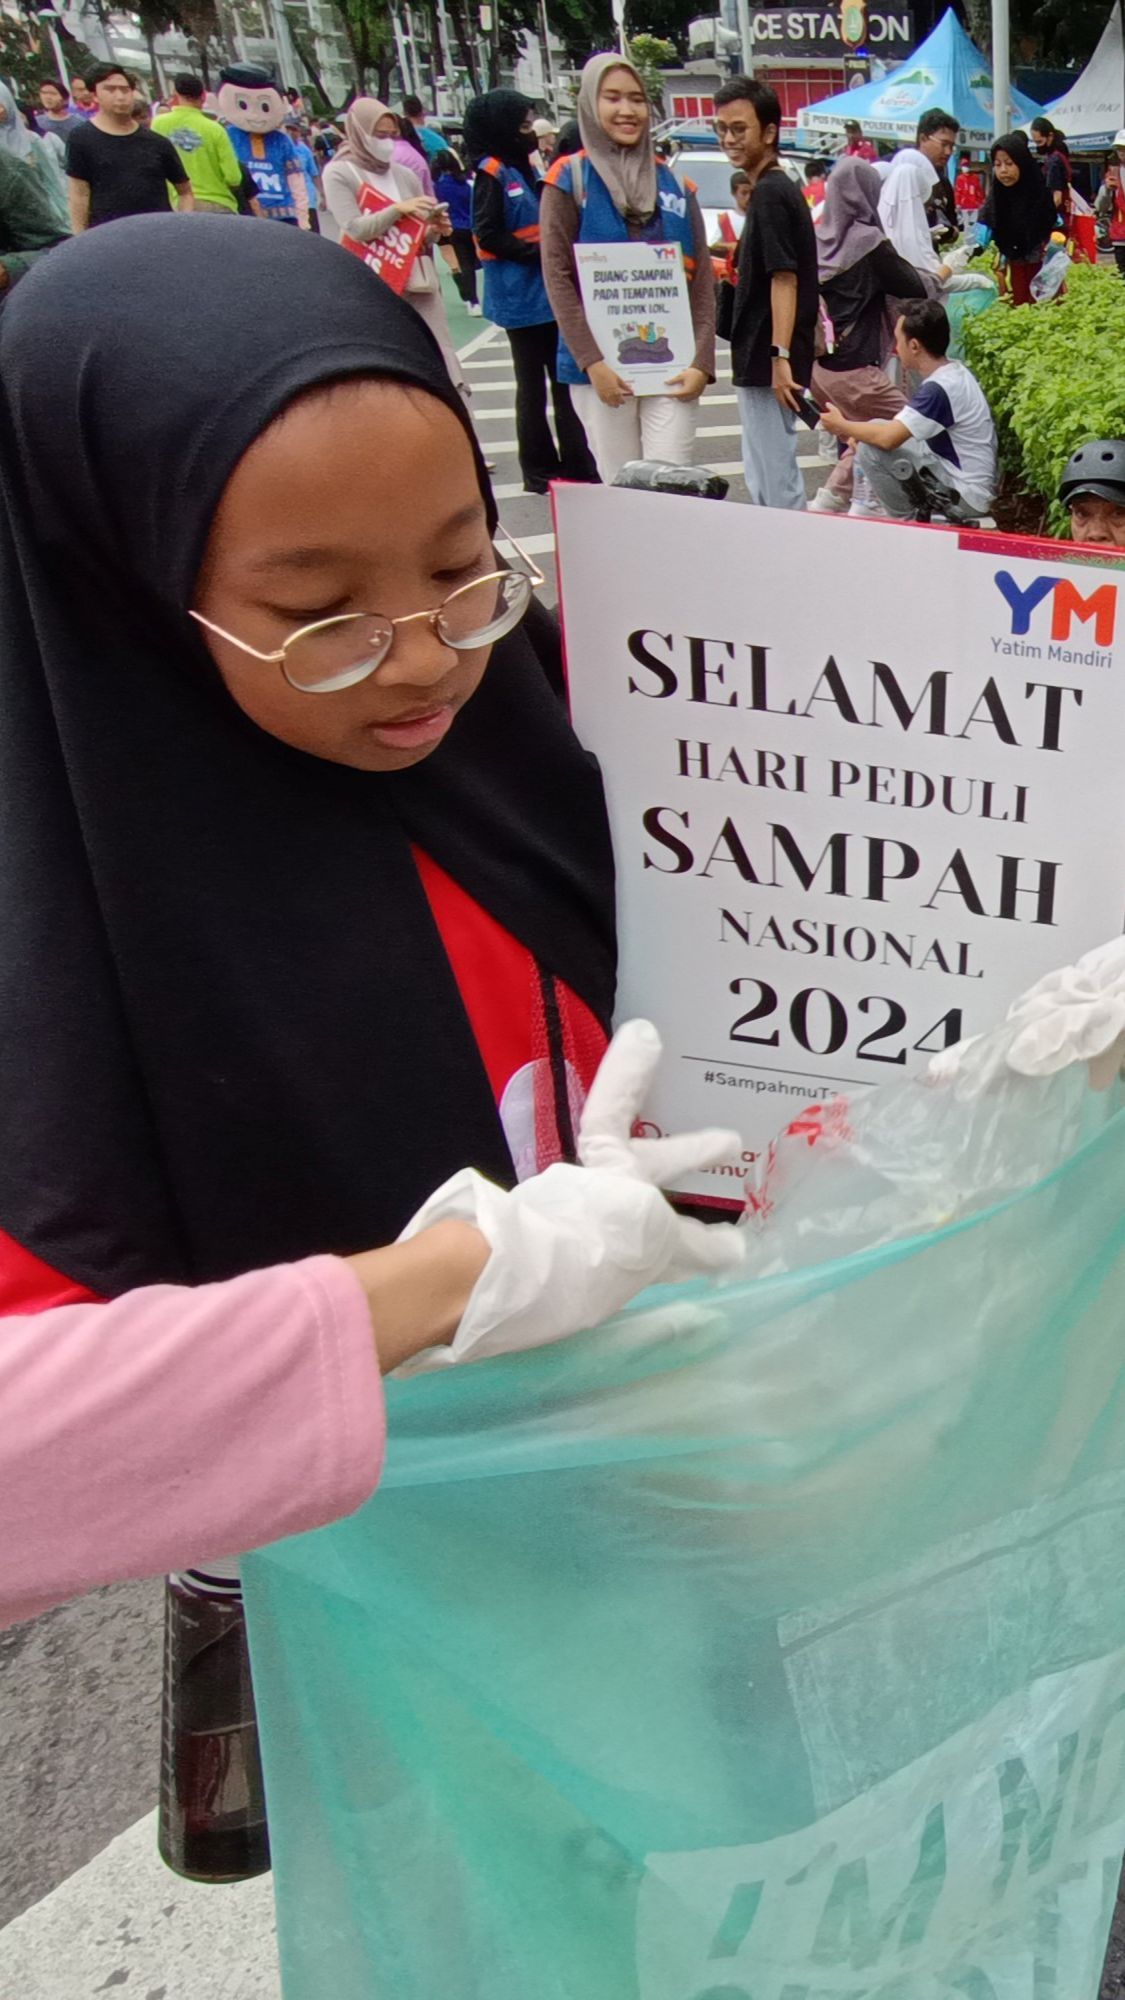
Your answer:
398,1020 -> 747,1374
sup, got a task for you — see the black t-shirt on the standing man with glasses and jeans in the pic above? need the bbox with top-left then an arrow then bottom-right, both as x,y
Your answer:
731,166 -> 817,388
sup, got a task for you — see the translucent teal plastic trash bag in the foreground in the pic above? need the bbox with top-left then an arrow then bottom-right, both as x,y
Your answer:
244,1072 -> 1125,2000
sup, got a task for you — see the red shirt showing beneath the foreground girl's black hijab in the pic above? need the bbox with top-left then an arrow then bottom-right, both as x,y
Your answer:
0,850 -> 607,1316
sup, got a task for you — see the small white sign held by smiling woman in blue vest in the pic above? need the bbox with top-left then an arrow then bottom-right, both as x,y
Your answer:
575,244 -> 695,396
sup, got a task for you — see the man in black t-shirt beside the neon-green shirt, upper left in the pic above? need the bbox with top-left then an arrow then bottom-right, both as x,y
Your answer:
66,62 -> 196,236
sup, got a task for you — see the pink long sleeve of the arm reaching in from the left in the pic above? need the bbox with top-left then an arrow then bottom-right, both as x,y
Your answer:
0,1256 -> 384,1624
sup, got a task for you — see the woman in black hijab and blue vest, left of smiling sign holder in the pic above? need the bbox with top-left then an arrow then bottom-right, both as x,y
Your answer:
464,90 -> 599,494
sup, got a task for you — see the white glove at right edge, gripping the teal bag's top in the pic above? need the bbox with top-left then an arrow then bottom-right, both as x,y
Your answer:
1007,938 -> 1125,1090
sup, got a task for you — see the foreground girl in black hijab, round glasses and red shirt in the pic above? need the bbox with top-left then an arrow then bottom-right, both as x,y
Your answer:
0,216 -> 615,1296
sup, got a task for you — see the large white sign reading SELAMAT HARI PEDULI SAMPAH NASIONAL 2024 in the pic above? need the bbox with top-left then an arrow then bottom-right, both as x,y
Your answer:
554,486 -> 1125,1198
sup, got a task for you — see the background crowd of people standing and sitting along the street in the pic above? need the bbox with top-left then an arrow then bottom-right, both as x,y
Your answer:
0,54 -> 1125,536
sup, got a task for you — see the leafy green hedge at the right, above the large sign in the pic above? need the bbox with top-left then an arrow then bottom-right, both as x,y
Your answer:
963,264 -> 1125,534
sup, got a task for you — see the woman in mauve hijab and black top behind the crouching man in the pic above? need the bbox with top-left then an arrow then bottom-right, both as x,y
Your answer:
811,158 -> 927,514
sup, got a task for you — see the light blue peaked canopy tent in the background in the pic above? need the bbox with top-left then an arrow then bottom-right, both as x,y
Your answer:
801,8 -> 1043,146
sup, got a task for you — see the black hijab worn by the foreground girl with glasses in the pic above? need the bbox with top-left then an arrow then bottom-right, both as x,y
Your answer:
0,216 -> 615,1294
